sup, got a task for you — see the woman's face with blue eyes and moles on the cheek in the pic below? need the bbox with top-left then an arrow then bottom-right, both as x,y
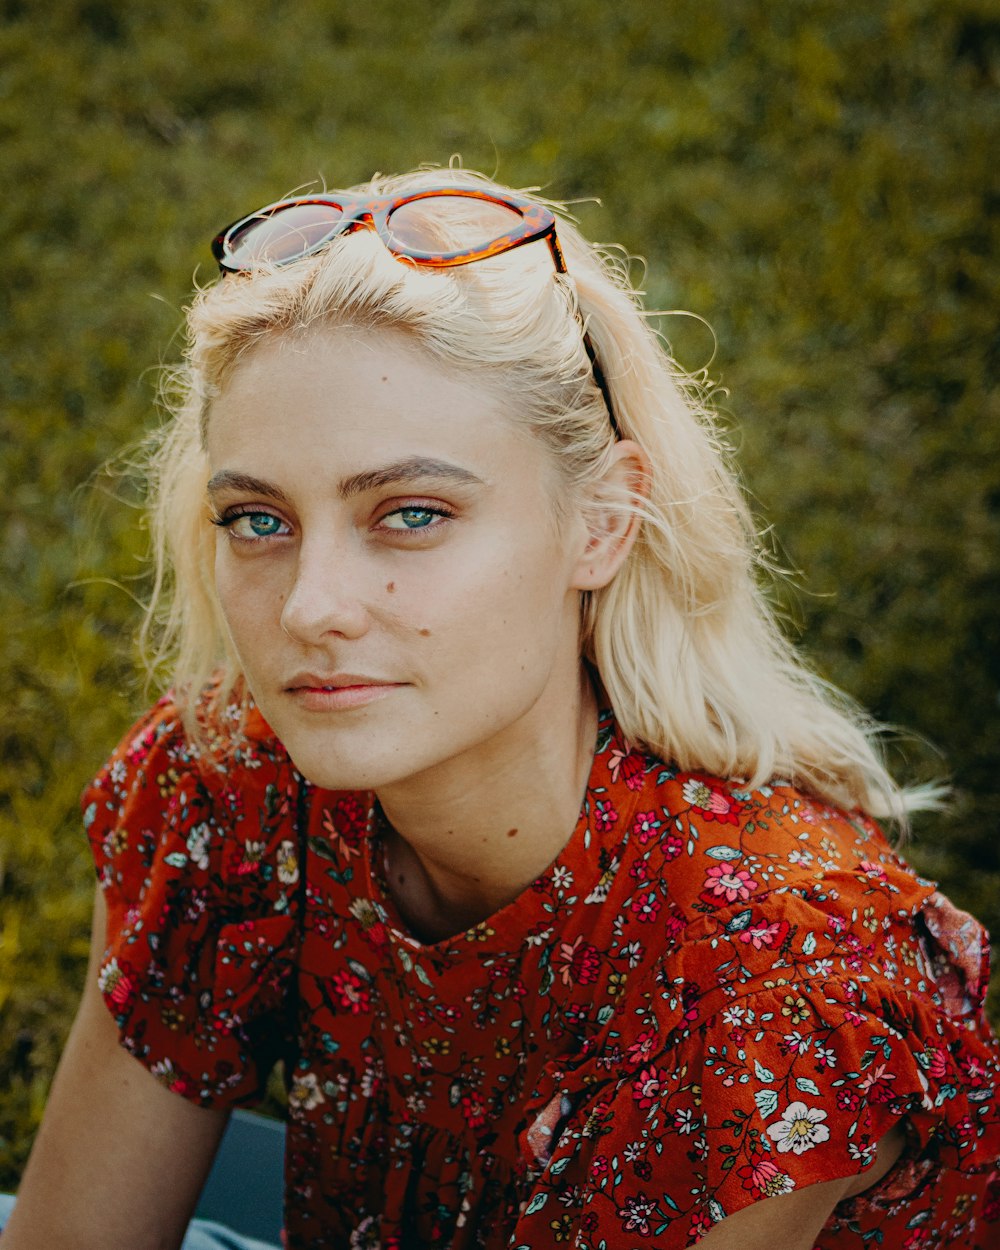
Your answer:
208,329 -> 588,789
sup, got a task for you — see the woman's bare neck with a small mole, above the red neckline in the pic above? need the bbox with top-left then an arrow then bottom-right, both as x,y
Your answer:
378,675 -> 598,941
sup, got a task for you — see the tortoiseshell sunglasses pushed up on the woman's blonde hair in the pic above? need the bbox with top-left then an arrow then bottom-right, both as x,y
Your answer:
211,186 -> 619,435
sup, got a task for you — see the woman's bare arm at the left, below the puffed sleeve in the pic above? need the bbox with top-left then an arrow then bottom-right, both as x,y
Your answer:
3,890 -> 226,1250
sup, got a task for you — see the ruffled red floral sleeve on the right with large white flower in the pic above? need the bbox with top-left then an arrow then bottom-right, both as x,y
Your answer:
511,864 -> 1000,1250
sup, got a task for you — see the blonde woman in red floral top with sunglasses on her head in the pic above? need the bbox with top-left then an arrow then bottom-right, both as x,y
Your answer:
4,170 -> 1000,1250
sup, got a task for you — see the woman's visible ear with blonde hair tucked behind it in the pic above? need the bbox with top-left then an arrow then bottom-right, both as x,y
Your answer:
573,439 -> 650,590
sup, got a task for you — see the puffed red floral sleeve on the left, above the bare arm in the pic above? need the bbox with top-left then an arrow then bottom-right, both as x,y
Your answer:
83,696 -> 304,1108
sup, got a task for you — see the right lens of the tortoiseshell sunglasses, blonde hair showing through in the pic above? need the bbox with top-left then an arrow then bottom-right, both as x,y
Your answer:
389,195 -> 521,255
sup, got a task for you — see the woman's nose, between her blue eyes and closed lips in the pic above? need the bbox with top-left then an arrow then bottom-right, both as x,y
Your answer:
281,543 -> 370,646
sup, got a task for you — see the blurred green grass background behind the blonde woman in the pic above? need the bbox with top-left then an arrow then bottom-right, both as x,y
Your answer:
0,0 -> 1000,1186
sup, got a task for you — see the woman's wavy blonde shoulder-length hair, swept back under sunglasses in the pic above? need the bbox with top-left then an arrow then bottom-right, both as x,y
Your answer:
144,169 -> 919,820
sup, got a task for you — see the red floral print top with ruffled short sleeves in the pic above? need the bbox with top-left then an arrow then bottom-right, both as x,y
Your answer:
84,700 -> 1000,1250
